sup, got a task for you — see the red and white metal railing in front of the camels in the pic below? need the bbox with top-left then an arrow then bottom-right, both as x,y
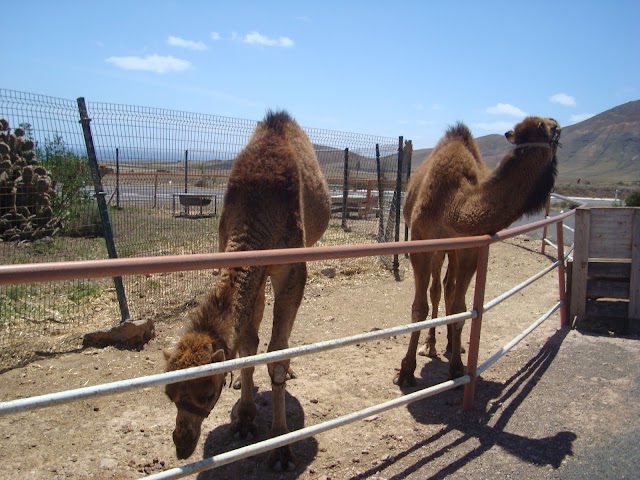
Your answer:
0,211 -> 574,479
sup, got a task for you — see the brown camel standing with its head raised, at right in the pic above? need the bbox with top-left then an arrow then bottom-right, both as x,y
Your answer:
394,117 -> 561,386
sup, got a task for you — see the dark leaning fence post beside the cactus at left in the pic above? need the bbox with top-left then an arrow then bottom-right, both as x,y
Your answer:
77,97 -> 130,323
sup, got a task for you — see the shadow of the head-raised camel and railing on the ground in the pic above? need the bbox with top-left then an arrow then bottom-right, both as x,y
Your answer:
352,329 -> 577,480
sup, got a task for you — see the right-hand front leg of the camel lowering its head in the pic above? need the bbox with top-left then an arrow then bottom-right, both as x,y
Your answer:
268,263 -> 307,470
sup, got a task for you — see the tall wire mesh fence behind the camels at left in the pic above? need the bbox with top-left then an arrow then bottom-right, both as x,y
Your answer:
0,89 -> 410,342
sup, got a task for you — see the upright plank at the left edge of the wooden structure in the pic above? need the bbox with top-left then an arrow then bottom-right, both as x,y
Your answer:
569,207 -> 590,323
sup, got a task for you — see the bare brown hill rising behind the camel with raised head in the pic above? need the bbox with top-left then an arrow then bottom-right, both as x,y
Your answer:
411,100 -> 640,184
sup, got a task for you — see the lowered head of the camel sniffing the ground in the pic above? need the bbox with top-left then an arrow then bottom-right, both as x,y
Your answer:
164,332 -> 226,460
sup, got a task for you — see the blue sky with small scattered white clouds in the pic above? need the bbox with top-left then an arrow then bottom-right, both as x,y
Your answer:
0,0 -> 640,148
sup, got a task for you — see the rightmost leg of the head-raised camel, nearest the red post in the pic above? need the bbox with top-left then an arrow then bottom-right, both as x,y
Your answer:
447,249 -> 478,378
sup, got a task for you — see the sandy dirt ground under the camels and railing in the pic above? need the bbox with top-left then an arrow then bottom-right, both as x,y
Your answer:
0,238 -> 640,480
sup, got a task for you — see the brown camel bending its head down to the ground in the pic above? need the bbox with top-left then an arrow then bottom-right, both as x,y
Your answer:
165,111 -> 331,469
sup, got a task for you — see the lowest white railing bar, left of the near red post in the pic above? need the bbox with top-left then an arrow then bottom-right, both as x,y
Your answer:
144,375 -> 470,480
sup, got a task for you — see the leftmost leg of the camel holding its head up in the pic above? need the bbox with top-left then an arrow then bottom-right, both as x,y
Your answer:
393,252 -> 433,387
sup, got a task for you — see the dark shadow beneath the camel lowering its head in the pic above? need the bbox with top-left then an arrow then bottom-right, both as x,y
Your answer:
197,388 -> 318,480
